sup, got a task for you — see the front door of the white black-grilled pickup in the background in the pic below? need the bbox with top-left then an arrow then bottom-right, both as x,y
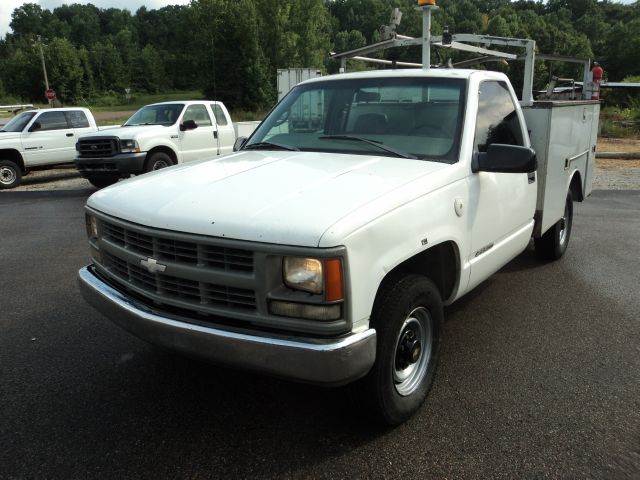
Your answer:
179,103 -> 218,162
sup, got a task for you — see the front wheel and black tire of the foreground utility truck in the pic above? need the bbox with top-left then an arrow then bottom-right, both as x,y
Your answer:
352,275 -> 444,426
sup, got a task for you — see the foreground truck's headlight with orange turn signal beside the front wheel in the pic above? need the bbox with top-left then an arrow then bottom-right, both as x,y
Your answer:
283,257 -> 344,302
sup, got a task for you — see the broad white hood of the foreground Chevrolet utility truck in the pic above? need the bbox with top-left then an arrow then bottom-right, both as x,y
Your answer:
87,151 -> 449,247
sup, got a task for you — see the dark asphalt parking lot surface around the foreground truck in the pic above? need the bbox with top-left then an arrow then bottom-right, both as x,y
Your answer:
0,186 -> 640,479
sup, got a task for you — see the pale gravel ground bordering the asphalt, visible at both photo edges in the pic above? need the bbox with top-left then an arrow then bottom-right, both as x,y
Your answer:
2,139 -> 640,191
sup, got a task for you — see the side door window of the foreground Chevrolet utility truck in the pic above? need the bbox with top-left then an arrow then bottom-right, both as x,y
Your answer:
474,81 -> 524,152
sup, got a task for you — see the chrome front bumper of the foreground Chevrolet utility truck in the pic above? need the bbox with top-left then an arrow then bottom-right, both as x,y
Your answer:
78,266 -> 376,386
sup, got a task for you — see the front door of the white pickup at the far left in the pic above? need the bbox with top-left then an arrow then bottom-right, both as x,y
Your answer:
21,110 -> 76,168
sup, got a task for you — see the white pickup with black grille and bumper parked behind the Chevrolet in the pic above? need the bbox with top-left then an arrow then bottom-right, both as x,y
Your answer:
75,100 -> 259,188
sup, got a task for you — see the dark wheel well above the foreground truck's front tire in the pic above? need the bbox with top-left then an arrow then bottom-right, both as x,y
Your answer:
376,241 -> 460,308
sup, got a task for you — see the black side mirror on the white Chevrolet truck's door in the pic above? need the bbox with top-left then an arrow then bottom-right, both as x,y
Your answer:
471,143 -> 538,173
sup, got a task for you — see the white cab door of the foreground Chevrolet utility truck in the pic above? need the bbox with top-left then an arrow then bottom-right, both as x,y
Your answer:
467,80 -> 537,288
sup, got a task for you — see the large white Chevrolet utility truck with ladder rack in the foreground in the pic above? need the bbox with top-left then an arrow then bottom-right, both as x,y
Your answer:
79,5 -> 599,425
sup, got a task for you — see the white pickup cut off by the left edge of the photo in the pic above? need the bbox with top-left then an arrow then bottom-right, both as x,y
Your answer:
0,108 -> 97,189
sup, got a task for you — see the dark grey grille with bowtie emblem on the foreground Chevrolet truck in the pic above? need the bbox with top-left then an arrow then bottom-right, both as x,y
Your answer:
100,221 -> 256,315
